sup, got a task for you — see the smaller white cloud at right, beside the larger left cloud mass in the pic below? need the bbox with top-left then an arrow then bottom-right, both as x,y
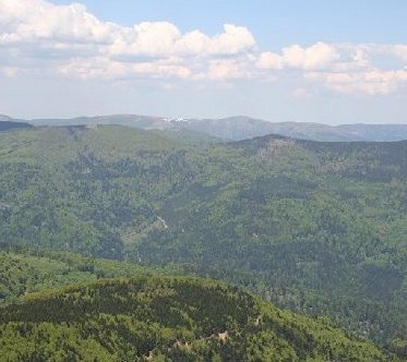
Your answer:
256,43 -> 407,95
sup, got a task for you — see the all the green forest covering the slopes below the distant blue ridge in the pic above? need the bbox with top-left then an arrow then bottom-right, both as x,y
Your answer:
0,126 -> 407,361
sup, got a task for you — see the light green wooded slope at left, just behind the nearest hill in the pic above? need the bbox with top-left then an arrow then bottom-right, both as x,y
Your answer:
0,249 -> 179,306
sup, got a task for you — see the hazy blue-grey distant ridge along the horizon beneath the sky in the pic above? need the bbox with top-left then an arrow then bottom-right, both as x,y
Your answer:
24,115 -> 407,142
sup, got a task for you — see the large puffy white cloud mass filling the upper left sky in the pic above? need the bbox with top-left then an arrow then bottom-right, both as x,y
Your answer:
0,0 -> 256,79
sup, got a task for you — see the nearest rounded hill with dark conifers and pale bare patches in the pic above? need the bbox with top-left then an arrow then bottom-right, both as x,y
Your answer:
0,276 -> 395,361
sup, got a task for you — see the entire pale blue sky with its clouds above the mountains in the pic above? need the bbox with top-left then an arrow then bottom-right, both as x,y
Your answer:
0,0 -> 407,125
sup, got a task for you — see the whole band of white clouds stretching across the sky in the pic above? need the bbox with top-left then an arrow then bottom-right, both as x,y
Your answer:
0,0 -> 407,96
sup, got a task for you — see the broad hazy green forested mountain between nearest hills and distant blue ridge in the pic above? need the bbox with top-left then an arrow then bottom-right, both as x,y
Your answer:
0,126 -> 407,355
